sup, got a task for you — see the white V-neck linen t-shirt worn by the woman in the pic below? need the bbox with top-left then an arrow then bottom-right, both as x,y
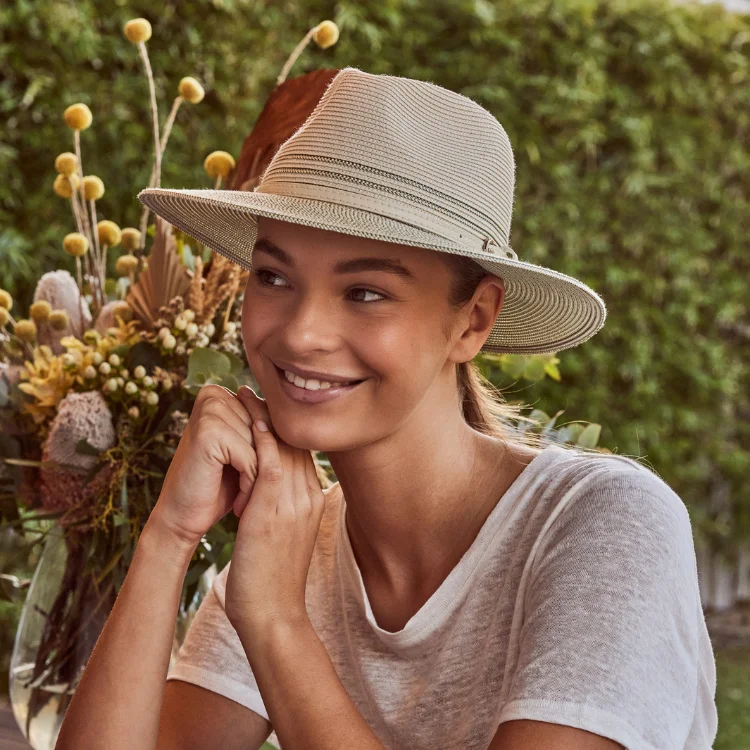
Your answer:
167,444 -> 717,750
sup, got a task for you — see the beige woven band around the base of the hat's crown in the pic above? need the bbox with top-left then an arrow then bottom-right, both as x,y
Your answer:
255,164 -> 518,260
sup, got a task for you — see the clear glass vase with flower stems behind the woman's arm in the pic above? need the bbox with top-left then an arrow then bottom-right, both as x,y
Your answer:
9,521 -> 216,750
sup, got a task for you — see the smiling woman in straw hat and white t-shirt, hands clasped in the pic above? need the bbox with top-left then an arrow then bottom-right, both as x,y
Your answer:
58,68 -> 716,750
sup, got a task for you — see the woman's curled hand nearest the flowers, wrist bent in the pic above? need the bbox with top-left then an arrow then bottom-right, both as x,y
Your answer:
151,384 -> 258,545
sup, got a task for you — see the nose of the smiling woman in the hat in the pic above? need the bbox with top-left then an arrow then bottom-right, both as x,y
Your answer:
281,293 -> 339,357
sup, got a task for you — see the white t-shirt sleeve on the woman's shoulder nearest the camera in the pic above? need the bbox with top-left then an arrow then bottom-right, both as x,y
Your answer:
499,459 -> 713,750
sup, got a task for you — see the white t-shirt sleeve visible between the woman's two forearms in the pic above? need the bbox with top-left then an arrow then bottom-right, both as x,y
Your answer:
167,561 -> 270,721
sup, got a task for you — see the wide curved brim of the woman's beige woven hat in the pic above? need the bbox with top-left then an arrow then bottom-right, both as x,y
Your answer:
138,188 -> 607,354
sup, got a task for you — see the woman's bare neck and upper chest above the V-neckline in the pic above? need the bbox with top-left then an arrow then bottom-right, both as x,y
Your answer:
329,402 -> 517,596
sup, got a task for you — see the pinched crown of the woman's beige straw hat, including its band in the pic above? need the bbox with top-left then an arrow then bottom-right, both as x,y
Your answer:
256,67 -> 515,255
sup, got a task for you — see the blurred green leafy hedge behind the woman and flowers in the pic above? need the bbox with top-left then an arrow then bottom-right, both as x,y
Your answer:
0,0 -> 750,552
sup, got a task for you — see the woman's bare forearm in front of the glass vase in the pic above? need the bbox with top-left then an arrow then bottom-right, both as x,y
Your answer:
55,515 -> 197,750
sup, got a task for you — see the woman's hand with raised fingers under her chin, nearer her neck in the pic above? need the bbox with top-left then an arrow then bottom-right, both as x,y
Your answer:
225,386 -> 325,640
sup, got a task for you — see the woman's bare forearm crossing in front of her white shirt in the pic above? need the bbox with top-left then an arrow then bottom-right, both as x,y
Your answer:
237,621 -> 385,750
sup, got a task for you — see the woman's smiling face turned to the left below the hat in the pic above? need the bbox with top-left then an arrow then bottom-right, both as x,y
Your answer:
242,217 -> 488,452
